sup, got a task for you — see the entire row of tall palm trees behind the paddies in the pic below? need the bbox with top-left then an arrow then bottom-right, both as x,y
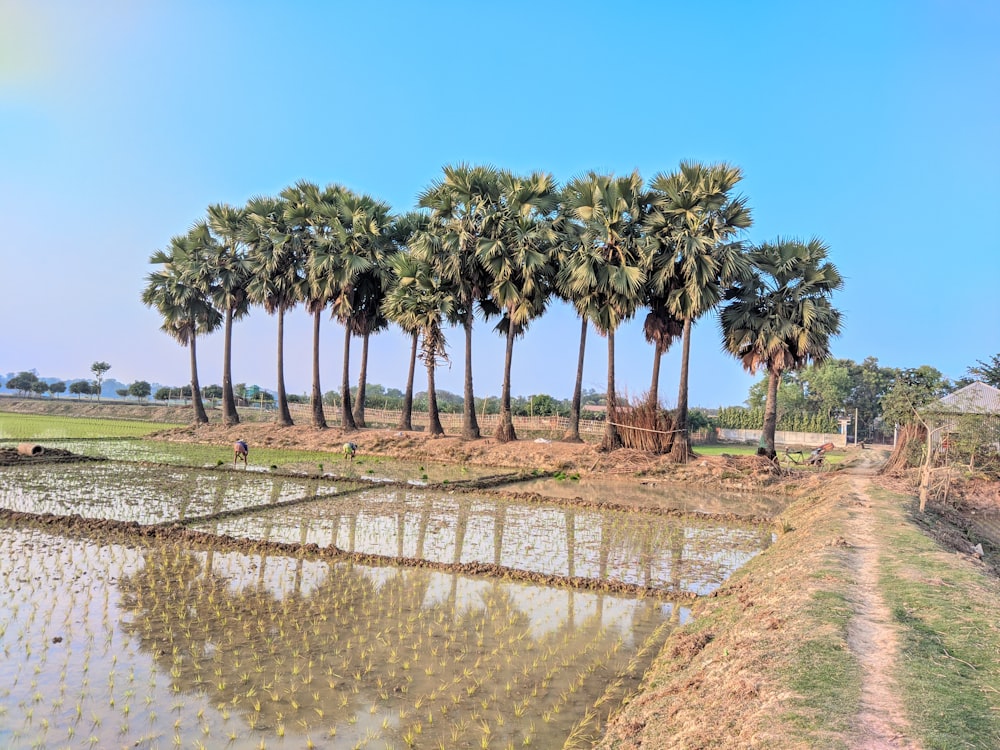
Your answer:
142,162 -> 842,461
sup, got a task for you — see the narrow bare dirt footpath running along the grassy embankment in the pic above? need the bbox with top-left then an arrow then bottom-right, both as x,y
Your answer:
847,467 -> 921,750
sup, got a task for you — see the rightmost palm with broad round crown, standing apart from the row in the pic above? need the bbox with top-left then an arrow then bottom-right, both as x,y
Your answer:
720,237 -> 844,460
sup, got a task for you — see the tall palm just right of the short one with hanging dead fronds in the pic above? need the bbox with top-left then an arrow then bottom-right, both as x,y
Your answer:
414,164 -> 500,440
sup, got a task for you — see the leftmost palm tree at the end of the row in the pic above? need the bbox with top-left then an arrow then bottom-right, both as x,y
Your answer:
142,230 -> 222,424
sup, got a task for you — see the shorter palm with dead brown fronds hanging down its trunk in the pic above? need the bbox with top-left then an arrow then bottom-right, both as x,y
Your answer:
382,252 -> 458,435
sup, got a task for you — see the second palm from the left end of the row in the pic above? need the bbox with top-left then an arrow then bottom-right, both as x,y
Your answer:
206,203 -> 250,425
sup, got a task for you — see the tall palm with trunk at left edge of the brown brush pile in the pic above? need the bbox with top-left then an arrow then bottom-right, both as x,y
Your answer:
559,171 -> 650,450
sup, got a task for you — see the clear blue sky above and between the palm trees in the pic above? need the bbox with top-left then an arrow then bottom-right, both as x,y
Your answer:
0,0 -> 1000,407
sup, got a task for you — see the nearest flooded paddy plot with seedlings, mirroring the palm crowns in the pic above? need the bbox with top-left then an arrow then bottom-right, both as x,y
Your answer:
0,526 -> 687,748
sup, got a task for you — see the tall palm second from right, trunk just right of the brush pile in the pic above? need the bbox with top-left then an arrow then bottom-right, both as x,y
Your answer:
645,162 -> 752,462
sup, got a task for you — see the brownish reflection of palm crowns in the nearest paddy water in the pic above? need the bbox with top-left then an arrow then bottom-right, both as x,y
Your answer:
120,534 -> 676,746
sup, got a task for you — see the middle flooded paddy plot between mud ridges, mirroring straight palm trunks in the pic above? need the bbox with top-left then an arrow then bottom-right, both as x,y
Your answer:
197,488 -> 771,594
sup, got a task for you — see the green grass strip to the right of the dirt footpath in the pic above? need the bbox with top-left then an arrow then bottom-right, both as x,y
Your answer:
880,493 -> 1000,748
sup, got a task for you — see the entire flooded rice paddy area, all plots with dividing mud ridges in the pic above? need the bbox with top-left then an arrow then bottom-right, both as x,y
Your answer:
0,441 -> 771,748
